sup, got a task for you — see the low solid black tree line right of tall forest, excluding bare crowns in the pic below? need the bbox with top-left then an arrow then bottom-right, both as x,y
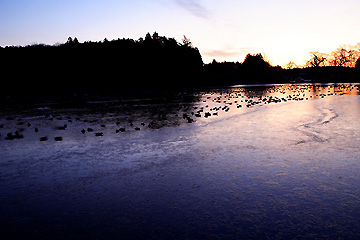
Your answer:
203,54 -> 360,85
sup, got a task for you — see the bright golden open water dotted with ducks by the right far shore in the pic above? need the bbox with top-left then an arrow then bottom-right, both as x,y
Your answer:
193,83 -> 360,121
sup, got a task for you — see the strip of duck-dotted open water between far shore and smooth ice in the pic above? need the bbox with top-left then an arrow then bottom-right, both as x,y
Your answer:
0,84 -> 359,140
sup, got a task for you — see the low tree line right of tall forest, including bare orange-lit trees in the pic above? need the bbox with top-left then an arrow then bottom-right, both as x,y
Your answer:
203,43 -> 360,85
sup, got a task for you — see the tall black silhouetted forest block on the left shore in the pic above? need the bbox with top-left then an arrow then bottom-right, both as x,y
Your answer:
0,32 -> 203,96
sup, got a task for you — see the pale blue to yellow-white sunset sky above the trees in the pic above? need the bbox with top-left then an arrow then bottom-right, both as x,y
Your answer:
0,0 -> 360,66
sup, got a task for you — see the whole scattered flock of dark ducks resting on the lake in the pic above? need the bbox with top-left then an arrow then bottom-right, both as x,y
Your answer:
0,85 -> 359,141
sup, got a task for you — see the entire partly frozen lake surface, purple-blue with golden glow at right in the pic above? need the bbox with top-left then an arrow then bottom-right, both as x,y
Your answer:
0,84 -> 360,239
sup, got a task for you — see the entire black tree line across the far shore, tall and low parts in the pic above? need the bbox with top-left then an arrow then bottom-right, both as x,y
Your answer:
0,32 -> 360,96
